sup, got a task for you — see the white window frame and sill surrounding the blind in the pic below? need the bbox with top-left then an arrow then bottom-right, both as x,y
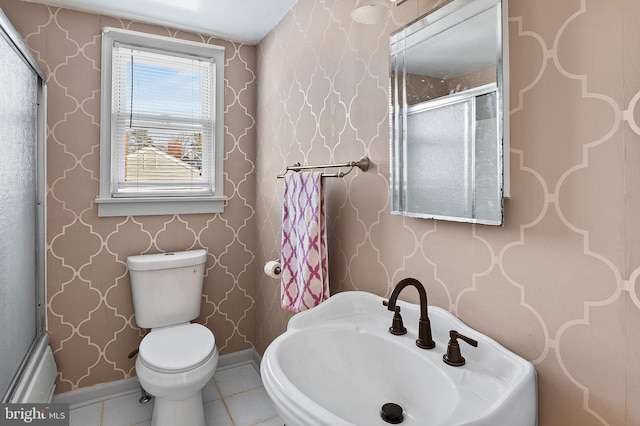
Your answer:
96,27 -> 226,217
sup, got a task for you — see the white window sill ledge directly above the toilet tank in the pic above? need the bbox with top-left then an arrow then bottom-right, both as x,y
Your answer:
96,197 -> 227,217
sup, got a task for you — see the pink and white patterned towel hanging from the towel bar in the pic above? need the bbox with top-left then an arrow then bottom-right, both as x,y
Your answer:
280,172 -> 329,312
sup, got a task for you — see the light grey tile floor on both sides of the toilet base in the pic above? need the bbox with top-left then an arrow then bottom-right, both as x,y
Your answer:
69,363 -> 284,426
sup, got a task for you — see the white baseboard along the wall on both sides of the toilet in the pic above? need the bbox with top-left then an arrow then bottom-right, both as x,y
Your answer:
54,348 -> 262,409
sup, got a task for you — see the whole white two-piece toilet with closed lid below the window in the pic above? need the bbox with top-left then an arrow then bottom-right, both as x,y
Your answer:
127,250 -> 218,426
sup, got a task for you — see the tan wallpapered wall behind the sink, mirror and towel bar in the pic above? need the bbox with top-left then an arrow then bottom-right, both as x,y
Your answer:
256,0 -> 640,426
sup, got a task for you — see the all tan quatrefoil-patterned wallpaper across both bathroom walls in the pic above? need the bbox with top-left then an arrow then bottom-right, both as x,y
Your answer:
0,0 -> 640,426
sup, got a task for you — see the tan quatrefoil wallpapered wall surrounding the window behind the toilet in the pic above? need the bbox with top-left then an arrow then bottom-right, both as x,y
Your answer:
0,0 -> 256,392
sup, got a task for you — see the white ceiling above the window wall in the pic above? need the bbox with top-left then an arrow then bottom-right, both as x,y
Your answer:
27,0 -> 297,44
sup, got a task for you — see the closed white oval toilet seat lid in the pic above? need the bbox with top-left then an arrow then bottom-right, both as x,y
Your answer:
138,324 -> 216,373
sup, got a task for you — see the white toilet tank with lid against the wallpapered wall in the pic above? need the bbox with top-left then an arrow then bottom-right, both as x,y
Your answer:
127,250 -> 207,328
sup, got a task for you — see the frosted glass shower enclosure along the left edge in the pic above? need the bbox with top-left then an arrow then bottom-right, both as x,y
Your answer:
0,9 -> 57,402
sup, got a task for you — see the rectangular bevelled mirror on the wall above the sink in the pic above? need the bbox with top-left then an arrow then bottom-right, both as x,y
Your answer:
389,0 -> 509,225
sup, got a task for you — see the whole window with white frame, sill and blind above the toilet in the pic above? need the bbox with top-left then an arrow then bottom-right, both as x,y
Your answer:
96,28 -> 224,216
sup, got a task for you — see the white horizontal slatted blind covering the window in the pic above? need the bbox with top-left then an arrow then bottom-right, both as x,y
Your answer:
111,42 -> 216,197
